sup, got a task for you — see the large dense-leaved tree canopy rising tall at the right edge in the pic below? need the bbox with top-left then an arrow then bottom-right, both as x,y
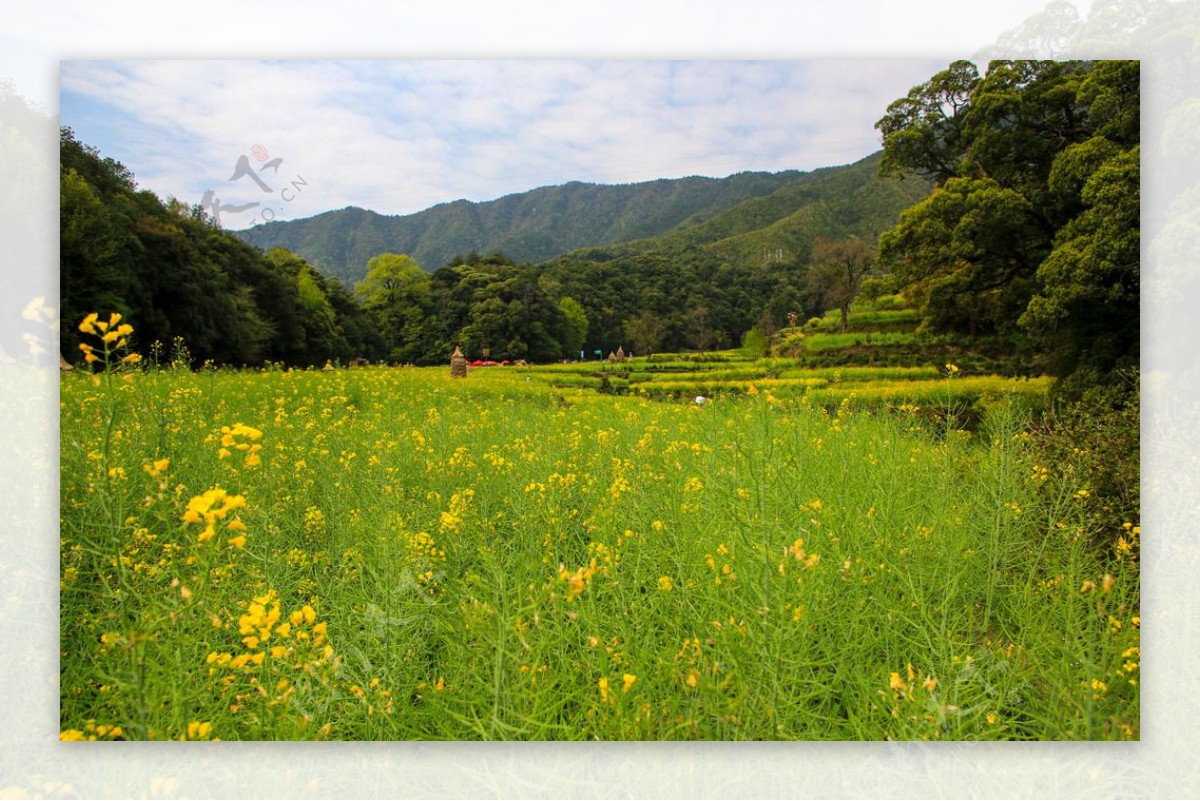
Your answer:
876,61 -> 1140,390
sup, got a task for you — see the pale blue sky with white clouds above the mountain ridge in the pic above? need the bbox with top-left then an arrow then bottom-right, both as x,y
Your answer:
60,58 -> 947,228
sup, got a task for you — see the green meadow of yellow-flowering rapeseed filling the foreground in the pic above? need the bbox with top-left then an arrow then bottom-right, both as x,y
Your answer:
60,362 -> 1140,740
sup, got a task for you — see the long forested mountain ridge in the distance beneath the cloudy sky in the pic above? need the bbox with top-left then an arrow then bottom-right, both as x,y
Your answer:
239,153 -> 930,287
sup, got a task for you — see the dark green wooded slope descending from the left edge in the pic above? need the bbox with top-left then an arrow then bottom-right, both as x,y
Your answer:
60,128 -> 377,365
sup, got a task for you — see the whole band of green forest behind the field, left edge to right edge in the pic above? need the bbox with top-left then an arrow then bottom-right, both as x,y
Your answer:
60,61 -> 1140,400
